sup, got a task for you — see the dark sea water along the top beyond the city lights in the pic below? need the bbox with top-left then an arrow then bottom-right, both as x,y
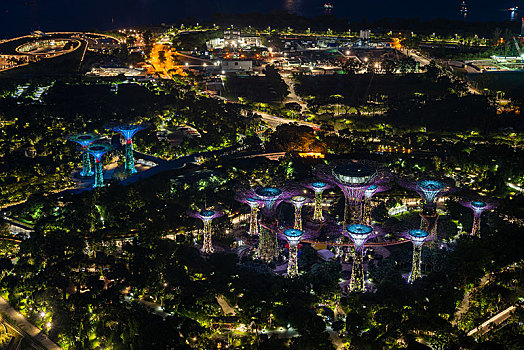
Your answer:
0,0 -> 524,38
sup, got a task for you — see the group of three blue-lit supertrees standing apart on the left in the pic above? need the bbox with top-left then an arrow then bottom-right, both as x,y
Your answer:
68,124 -> 145,187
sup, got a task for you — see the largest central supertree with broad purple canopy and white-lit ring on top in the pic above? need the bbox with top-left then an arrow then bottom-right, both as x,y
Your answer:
316,160 -> 390,229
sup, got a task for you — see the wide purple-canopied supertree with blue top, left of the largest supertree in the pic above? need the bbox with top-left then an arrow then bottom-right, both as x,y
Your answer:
237,186 -> 297,260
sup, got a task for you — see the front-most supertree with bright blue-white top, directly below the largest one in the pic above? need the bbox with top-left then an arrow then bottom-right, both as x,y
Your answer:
344,224 -> 373,292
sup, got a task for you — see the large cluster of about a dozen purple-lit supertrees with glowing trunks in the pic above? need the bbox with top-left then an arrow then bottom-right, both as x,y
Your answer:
190,160 -> 496,292
